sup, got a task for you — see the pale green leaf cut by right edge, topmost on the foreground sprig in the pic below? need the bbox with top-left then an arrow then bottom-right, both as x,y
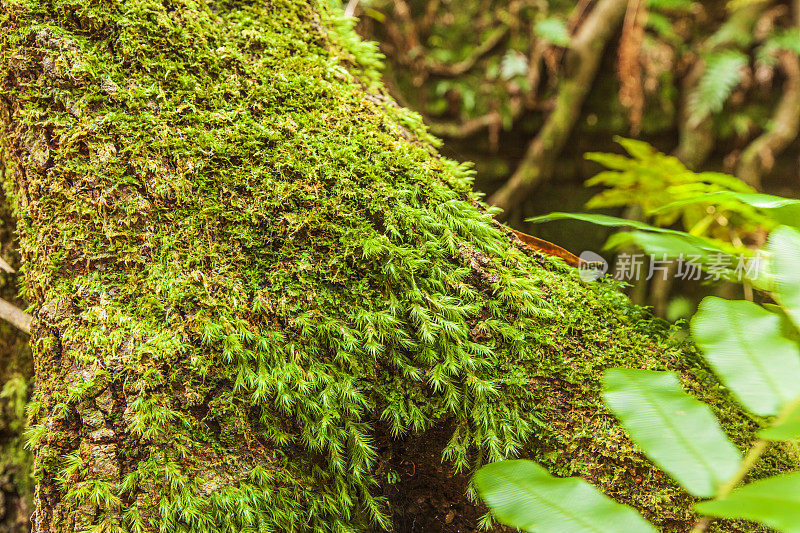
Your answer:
767,226 -> 800,328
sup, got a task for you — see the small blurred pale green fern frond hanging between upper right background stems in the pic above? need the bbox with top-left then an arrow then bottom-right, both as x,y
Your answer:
689,50 -> 747,124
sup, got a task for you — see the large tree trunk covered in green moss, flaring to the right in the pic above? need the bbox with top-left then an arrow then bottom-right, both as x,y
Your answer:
0,0 -> 796,533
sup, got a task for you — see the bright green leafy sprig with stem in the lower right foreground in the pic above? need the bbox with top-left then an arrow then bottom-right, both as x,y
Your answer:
475,210 -> 800,533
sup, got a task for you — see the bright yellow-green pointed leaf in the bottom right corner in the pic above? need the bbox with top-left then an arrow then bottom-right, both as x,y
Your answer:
694,472 -> 800,533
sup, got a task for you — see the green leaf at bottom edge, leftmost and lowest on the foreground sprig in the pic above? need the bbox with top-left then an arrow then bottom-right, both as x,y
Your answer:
475,460 -> 656,533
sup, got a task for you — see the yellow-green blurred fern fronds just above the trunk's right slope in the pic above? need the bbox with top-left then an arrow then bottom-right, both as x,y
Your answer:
530,138 -> 800,280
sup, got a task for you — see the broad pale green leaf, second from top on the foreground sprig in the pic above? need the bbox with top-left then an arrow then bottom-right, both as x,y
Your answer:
691,296 -> 800,416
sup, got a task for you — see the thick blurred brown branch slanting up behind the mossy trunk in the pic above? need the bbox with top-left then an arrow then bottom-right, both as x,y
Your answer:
489,0 -> 627,216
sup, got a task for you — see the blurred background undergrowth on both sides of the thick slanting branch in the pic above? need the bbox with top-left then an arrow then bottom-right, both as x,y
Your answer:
356,0 -> 800,192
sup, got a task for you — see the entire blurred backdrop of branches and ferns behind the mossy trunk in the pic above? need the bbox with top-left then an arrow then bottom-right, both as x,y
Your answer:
356,0 -> 800,211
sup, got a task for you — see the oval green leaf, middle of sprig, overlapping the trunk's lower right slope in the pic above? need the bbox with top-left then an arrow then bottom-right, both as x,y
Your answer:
603,368 -> 742,498
